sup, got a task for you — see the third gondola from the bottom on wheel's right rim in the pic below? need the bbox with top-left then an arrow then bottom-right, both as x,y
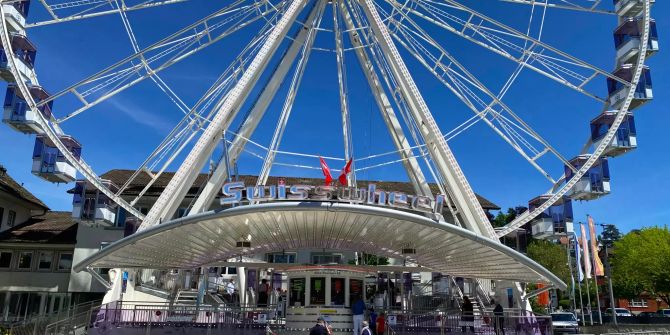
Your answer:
591,110 -> 637,157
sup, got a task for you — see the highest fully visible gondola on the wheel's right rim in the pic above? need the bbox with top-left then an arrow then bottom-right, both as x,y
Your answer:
614,18 -> 658,64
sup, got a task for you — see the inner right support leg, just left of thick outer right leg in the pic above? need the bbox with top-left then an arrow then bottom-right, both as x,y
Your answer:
340,1 -> 433,198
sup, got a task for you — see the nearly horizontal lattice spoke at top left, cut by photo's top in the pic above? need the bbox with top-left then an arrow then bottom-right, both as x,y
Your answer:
26,0 -> 193,28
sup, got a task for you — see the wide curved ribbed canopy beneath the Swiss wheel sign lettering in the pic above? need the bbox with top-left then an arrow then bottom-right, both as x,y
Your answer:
75,202 -> 566,289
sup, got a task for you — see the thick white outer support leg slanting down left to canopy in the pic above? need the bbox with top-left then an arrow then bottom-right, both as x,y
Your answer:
143,0 -> 312,231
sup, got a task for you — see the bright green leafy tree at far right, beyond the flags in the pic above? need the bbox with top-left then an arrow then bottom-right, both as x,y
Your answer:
610,227 -> 670,304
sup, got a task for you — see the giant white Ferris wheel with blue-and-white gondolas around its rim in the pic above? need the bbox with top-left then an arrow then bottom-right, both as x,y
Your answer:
0,0 -> 658,238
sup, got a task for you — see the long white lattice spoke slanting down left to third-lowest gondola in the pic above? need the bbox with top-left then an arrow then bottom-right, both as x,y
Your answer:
38,0 -> 277,123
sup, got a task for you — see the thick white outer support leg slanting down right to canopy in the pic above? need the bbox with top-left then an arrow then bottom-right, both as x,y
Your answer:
359,0 -> 497,240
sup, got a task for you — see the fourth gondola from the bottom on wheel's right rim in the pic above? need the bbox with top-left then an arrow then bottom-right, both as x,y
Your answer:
607,64 -> 654,111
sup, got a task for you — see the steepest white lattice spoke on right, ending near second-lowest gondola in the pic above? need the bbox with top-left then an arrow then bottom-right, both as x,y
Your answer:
389,5 -> 570,185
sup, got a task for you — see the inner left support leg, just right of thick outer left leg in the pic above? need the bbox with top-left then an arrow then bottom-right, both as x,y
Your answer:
188,1 -> 326,215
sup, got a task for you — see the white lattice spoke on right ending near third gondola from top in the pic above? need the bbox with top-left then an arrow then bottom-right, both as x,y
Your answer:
386,0 -> 630,103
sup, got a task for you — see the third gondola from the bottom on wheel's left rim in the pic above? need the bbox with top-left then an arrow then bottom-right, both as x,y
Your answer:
2,84 -> 53,134
